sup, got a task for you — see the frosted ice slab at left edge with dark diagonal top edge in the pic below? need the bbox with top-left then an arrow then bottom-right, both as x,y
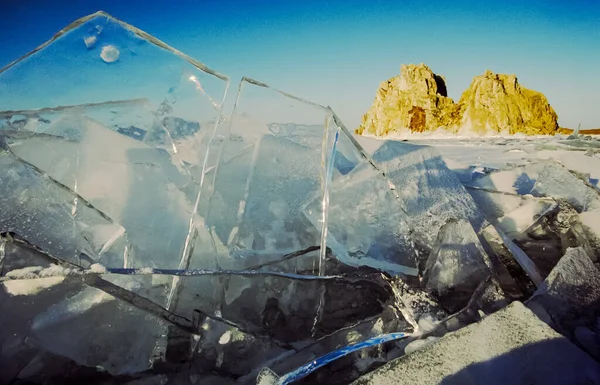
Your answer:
0,147 -> 129,267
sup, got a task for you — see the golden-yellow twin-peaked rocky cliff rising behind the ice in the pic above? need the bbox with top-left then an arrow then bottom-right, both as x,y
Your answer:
357,64 -> 558,136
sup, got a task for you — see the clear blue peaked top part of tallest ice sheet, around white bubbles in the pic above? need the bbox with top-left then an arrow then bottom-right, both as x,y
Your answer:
0,12 -> 228,117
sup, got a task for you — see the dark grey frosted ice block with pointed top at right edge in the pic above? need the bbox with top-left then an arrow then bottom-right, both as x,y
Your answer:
527,248 -> 600,335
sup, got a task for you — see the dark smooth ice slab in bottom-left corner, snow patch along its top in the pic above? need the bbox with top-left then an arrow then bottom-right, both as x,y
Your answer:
0,241 -> 167,376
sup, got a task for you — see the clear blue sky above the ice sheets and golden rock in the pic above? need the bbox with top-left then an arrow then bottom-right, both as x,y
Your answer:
0,0 -> 600,128
